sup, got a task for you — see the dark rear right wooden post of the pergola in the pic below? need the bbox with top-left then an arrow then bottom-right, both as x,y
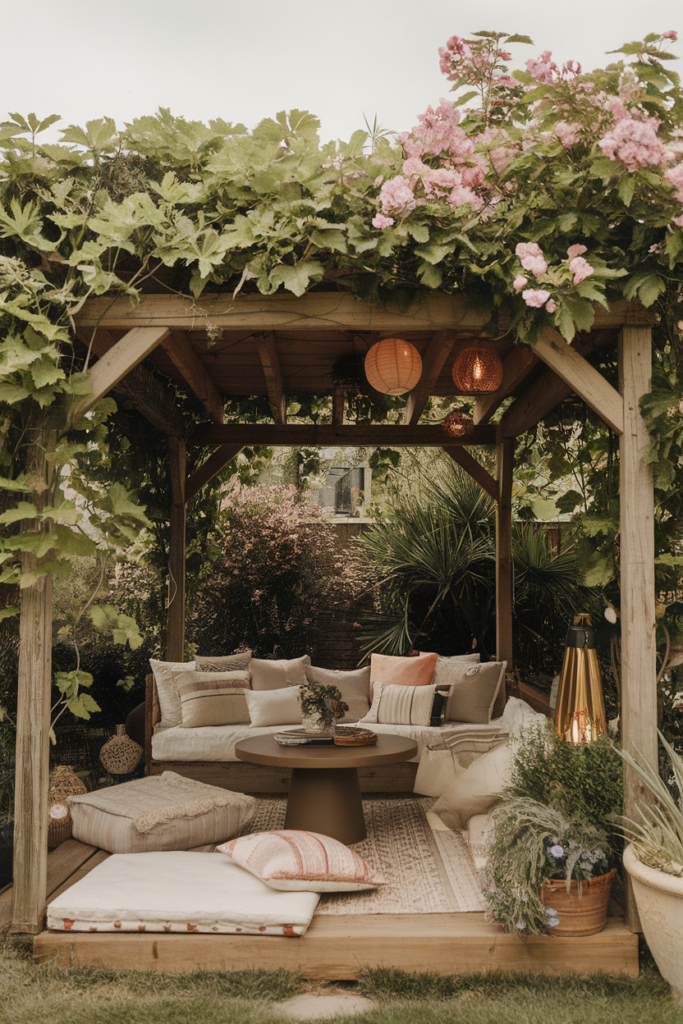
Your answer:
496,437 -> 515,671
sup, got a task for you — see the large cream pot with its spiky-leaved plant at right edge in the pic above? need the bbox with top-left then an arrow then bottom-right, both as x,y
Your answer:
622,733 -> 683,1004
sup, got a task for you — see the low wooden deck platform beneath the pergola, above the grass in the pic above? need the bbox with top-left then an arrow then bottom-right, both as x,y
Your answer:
14,840 -> 638,980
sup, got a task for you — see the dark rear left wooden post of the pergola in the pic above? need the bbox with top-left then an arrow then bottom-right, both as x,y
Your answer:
166,437 -> 186,662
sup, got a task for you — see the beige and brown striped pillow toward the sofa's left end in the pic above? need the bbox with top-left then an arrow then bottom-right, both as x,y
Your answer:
177,671 -> 251,729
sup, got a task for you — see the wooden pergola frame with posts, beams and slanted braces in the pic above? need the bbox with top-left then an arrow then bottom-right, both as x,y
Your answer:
12,292 -> 656,941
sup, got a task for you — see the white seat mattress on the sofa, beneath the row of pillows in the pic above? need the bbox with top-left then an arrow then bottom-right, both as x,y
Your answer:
152,719 -> 500,761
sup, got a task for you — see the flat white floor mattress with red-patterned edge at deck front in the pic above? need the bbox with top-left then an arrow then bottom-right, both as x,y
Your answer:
47,852 -> 319,936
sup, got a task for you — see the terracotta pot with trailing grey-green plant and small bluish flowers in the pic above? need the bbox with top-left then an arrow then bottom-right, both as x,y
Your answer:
484,797 -> 615,935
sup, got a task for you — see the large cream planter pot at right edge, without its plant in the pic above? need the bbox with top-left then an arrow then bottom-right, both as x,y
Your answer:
624,846 -> 683,1004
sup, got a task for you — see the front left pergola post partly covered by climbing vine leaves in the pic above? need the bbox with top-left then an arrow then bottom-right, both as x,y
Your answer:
11,428 -> 52,935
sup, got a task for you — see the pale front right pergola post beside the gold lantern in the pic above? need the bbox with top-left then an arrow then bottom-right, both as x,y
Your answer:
618,327 -> 657,931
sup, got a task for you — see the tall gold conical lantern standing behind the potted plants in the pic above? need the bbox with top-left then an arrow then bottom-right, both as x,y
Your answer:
555,614 -> 607,743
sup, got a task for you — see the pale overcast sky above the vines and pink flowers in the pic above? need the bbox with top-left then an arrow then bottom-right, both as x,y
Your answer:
0,0 -> 683,140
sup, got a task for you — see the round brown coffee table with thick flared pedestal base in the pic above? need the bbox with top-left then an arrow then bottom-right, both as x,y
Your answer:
234,735 -> 418,846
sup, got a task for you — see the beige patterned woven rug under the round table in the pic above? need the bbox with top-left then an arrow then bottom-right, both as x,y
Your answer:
237,797 -> 484,913
